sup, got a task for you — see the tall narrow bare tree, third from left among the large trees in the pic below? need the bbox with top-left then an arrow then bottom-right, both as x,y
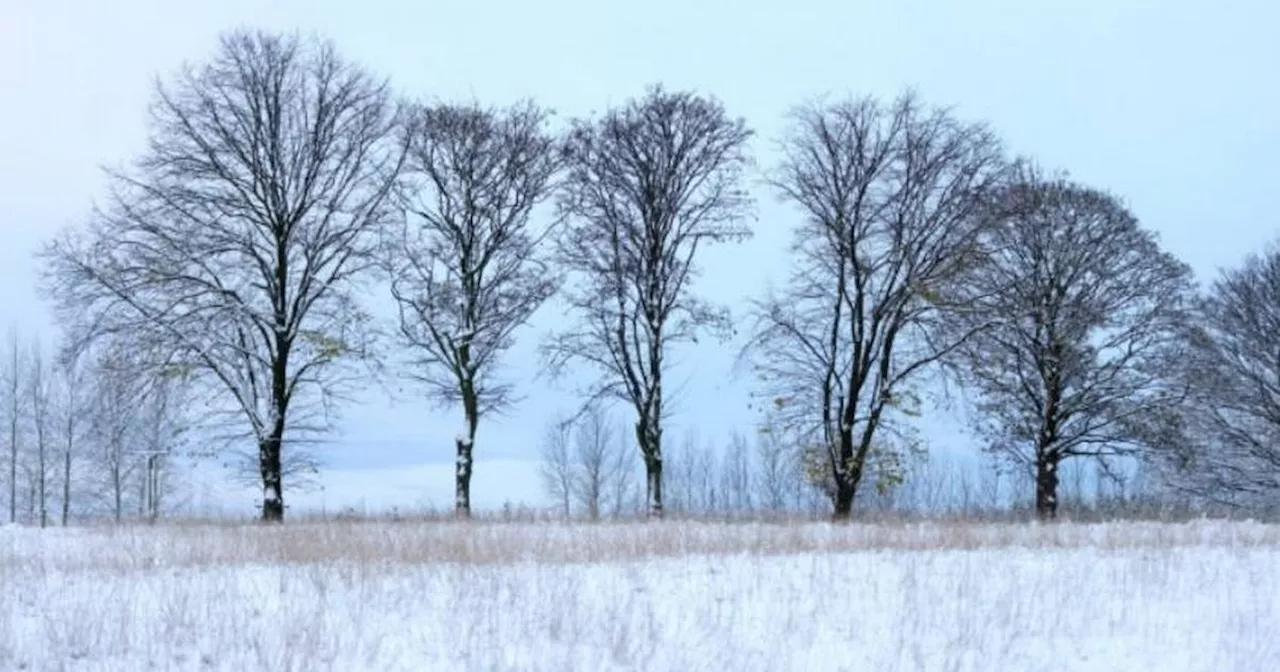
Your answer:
545,82 -> 751,517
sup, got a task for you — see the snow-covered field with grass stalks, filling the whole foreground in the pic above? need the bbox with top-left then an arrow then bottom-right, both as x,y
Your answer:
0,521 -> 1280,672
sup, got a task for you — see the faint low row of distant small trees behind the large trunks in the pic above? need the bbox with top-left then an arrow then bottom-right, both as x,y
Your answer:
541,410 -> 1167,520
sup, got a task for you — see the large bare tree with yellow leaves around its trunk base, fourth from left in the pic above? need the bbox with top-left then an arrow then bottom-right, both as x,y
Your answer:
744,93 -> 1005,518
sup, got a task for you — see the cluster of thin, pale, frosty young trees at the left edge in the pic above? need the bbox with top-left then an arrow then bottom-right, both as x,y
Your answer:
0,332 -> 186,527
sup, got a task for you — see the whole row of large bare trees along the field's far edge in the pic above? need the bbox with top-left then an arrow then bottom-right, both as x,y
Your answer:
30,32 -> 1280,520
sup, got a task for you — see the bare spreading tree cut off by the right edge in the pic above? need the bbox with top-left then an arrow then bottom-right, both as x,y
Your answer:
1158,243 -> 1280,509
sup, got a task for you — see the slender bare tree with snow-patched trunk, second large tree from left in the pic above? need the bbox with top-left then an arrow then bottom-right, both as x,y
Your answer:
387,96 -> 559,515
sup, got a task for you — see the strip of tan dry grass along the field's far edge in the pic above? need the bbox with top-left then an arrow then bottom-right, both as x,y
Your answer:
0,520 -> 1280,571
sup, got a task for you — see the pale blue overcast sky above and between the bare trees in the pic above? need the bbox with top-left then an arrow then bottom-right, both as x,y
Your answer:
0,0 -> 1280,509
